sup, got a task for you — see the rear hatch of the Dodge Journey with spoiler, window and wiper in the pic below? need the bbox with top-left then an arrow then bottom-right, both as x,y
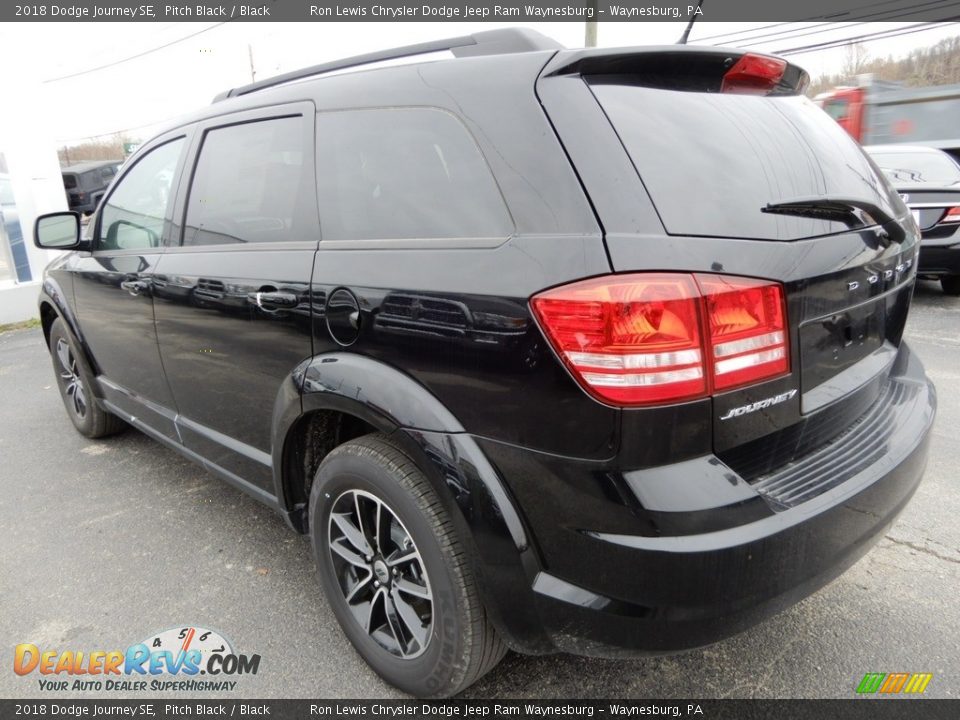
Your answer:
538,47 -> 917,479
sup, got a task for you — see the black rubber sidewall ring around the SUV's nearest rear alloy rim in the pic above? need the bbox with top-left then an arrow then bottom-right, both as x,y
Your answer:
310,444 -> 465,697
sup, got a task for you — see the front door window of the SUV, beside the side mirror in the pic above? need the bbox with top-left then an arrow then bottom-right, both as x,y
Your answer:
97,138 -> 184,250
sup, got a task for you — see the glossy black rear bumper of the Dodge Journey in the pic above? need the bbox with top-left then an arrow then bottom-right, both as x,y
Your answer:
479,345 -> 936,656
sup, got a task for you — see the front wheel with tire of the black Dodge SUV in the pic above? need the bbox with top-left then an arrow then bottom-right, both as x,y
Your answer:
50,318 -> 126,438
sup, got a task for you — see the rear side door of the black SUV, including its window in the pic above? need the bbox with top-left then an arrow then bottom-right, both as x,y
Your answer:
154,103 -> 319,494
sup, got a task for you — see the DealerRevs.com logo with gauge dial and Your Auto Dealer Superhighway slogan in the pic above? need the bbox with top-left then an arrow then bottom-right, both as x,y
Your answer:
13,627 -> 260,692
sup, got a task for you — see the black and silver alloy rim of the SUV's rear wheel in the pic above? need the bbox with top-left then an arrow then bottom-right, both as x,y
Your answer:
327,490 -> 433,660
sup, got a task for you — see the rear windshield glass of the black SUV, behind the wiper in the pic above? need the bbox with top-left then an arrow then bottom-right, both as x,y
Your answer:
592,83 -> 896,240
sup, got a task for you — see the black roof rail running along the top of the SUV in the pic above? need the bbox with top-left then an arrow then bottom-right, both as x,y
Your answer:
213,28 -> 564,102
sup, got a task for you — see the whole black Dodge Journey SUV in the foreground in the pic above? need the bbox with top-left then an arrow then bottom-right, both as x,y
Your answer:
36,31 -> 936,696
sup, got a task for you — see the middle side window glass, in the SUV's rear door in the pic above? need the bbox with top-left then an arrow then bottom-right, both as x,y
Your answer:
183,117 -> 308,245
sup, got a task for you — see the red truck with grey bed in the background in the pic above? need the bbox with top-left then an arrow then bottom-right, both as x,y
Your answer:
815,75 -> 960,159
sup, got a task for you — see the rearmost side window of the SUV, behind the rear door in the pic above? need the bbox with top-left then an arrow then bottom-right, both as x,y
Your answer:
317,108 -> 513,240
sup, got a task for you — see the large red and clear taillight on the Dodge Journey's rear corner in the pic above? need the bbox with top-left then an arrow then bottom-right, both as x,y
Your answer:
531,273 -> 790,405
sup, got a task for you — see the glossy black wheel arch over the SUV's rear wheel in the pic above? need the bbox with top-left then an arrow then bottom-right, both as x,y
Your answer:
273,352 -> 555,654
